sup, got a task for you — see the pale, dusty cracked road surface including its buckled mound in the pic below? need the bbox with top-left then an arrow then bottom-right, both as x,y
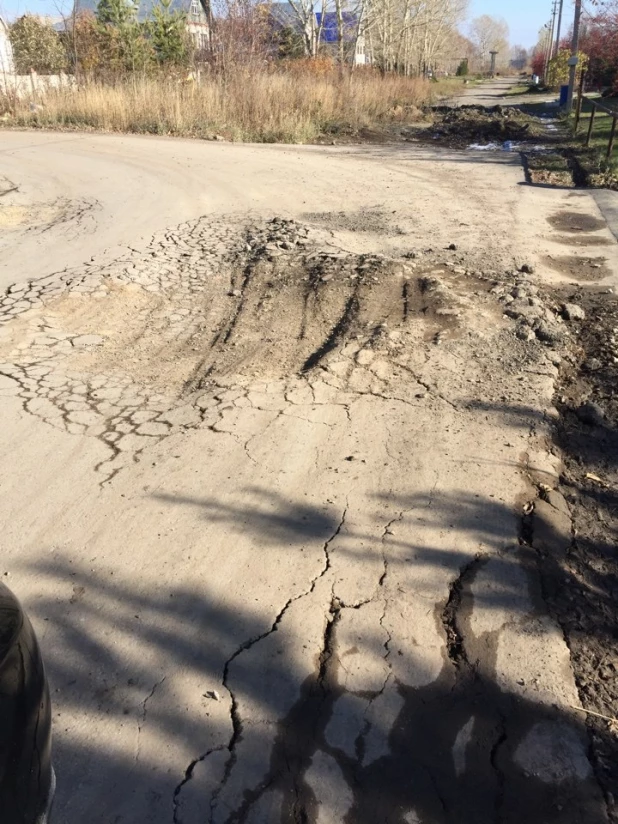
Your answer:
0,122 -> 618,824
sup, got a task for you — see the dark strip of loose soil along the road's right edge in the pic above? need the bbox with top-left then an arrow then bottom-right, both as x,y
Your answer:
542,282 -> 618,822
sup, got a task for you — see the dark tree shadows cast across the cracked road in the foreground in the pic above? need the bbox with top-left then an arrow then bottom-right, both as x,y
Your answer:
14,482 -> 604,824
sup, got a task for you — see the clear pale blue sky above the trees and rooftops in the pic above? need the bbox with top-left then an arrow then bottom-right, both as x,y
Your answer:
0,0 -> 560,47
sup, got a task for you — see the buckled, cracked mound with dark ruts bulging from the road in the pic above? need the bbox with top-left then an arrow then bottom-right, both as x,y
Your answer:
0,218 -> 500,478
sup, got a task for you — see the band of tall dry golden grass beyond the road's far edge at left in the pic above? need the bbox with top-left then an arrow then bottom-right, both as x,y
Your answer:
2,70 -> 434,143
